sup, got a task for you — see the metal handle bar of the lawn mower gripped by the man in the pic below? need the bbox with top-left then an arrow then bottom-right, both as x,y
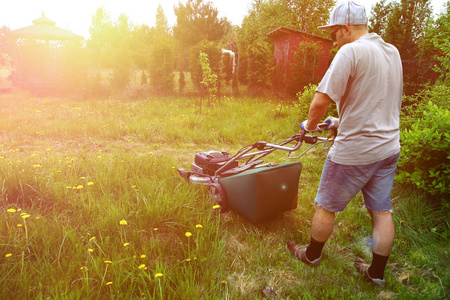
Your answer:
214,123 -> 337,176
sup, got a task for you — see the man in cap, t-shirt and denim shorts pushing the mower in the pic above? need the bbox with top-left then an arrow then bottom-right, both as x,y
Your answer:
287,1 -> 403,286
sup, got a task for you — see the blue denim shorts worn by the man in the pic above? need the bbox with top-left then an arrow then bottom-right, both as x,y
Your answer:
315,153 -> 400,212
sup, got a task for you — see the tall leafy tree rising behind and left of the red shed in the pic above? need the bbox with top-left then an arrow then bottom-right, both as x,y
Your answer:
238,0 -> 334,92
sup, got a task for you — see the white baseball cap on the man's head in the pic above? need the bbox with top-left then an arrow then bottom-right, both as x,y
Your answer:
317,1 -> 368,30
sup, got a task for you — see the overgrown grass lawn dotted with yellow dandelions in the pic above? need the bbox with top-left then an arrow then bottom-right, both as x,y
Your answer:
0,92 -> 450,299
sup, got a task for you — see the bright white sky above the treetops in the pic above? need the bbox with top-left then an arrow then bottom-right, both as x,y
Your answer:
0,0 -> 447,39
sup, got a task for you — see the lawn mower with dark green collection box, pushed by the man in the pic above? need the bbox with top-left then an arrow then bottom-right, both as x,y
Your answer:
177,123 -> 337,223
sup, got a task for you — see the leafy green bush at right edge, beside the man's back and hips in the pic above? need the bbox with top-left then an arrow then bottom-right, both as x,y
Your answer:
397,99 -> 450,199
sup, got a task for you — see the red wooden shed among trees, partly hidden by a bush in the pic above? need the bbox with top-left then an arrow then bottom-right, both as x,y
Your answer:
267,26 -> 333,95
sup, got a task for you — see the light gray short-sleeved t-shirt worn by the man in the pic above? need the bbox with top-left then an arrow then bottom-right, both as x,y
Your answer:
316,33 -> 403,165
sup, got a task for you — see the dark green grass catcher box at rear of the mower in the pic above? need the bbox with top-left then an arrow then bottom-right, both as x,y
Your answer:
219,162 -> 302,223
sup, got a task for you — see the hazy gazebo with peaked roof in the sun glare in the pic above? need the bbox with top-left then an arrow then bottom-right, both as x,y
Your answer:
7,13 -> 83,93
